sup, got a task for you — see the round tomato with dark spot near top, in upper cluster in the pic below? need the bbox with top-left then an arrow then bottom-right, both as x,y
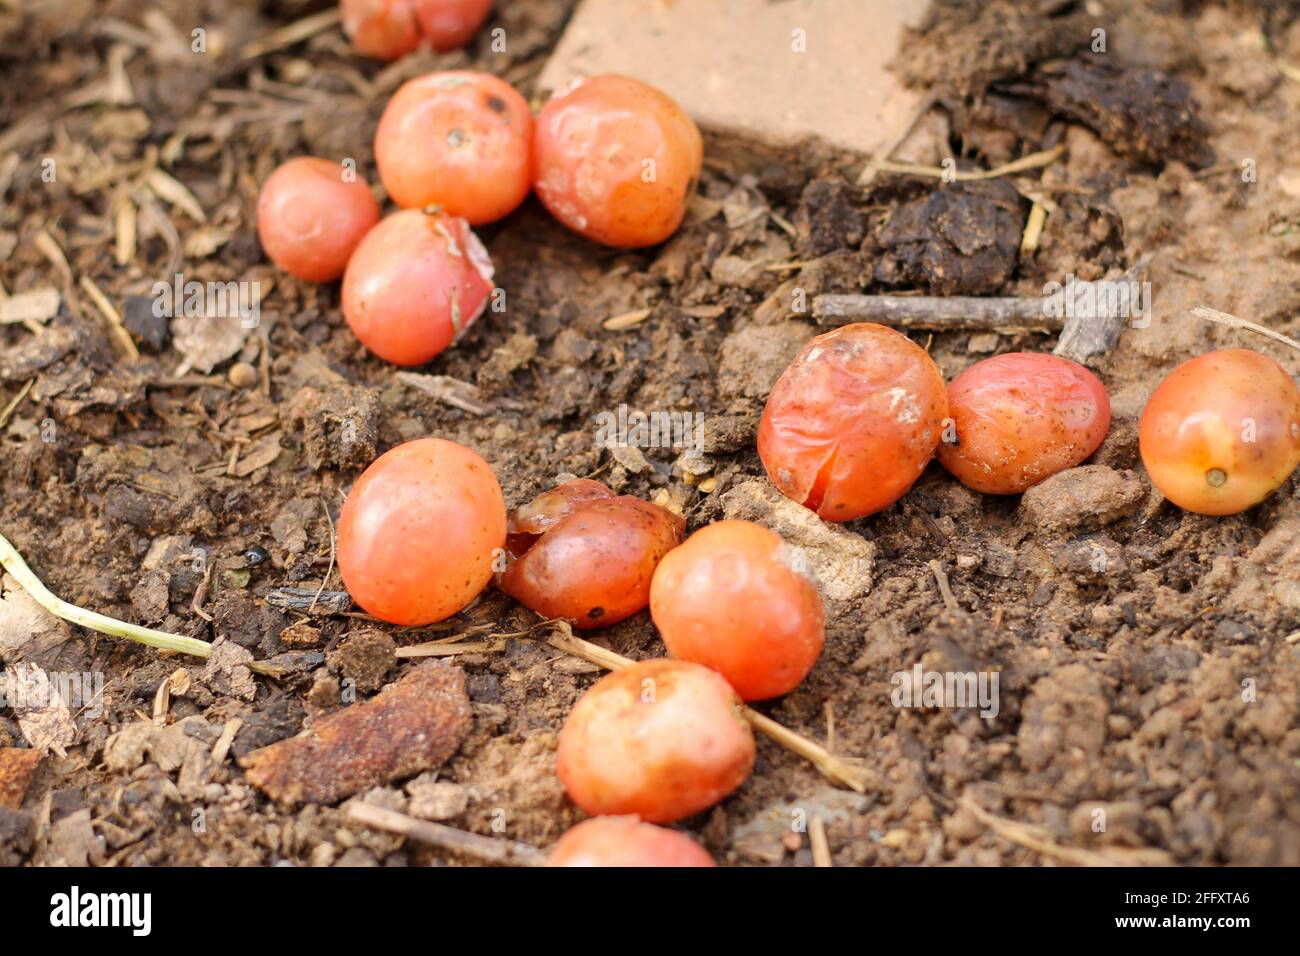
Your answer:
374,70 -> 533,225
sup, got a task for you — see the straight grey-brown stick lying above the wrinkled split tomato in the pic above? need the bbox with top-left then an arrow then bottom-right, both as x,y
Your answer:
813,294 -> 1065,332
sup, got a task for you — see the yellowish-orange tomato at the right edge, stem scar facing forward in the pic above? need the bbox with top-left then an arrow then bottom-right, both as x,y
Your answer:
1138,349 -> 1300,515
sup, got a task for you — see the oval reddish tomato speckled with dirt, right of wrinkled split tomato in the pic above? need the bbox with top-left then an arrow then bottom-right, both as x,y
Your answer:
937,352 -> 1110,494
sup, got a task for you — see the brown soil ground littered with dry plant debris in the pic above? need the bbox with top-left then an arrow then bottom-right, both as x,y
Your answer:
0,0 -> 1300,865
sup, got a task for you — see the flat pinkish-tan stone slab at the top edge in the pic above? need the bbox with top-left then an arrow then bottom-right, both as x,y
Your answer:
540,0 -> 930,165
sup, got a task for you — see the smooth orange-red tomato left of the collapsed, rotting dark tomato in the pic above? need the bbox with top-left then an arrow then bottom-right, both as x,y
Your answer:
338,438 -> 506,626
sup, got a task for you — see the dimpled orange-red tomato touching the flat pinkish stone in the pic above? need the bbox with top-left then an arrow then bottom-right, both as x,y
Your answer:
533,75 -> 703,248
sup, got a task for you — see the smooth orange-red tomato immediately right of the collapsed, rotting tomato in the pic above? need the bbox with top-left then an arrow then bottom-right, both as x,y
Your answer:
650,520 -> 826,701
